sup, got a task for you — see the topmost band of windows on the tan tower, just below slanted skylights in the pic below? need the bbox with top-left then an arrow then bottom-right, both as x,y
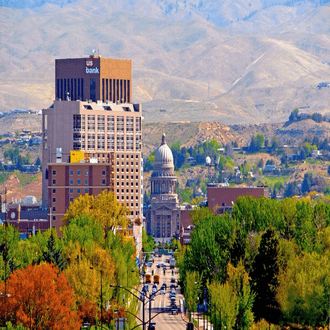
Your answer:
73,115 -> 141,134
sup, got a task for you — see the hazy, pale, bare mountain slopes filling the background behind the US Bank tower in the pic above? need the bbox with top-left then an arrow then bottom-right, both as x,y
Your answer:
0,0 -> 330,124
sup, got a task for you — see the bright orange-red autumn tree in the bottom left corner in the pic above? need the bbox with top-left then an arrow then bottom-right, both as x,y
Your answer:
0,264 -> 81,330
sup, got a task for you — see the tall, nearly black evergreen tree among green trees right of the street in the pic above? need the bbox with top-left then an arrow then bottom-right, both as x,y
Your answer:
251,228 -> 279,317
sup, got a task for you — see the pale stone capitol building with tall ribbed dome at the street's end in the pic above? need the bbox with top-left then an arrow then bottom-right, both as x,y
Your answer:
144,133 -> 181,243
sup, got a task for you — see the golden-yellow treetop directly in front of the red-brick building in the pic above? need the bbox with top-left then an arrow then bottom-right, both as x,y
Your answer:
62,190 -> 129,229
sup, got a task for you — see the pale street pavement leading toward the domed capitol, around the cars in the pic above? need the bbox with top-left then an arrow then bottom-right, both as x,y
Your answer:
139,255 -> 187,330
